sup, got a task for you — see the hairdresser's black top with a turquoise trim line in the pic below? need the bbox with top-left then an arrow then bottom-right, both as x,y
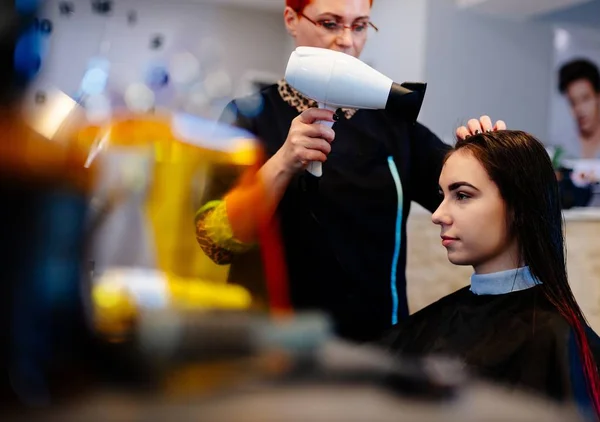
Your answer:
211,85 -> 450,341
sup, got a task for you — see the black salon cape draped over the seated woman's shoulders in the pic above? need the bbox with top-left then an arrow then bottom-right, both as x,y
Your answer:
383,286 -> 600,418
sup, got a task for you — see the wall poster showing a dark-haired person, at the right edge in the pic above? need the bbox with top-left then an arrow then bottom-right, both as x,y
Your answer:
549,28 -> 600,207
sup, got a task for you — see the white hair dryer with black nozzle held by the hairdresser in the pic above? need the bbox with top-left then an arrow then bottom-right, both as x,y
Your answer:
285,47 -> 427,177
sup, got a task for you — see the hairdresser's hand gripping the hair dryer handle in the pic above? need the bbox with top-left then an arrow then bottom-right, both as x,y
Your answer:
274,108 -> 335,174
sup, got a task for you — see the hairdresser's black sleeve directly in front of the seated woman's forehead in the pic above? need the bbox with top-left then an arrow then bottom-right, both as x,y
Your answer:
410,123 -> 451,212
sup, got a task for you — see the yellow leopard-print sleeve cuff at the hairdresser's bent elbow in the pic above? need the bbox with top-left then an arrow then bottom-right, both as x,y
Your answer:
196,200 -> 254,265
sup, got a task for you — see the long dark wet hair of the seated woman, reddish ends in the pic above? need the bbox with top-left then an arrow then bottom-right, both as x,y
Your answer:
448,130 -> 600,415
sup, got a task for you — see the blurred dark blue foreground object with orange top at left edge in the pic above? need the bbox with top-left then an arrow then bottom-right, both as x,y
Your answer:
0,104 -> 93,404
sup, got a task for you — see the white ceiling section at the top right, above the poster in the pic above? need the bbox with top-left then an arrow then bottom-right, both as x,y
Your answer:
455,0 -> 592,18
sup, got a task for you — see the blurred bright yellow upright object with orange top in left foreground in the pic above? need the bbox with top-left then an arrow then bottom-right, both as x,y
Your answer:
78,114 -> 260,283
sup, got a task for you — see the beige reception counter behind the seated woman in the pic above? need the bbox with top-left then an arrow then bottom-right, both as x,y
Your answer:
406,204 -> 600,333
